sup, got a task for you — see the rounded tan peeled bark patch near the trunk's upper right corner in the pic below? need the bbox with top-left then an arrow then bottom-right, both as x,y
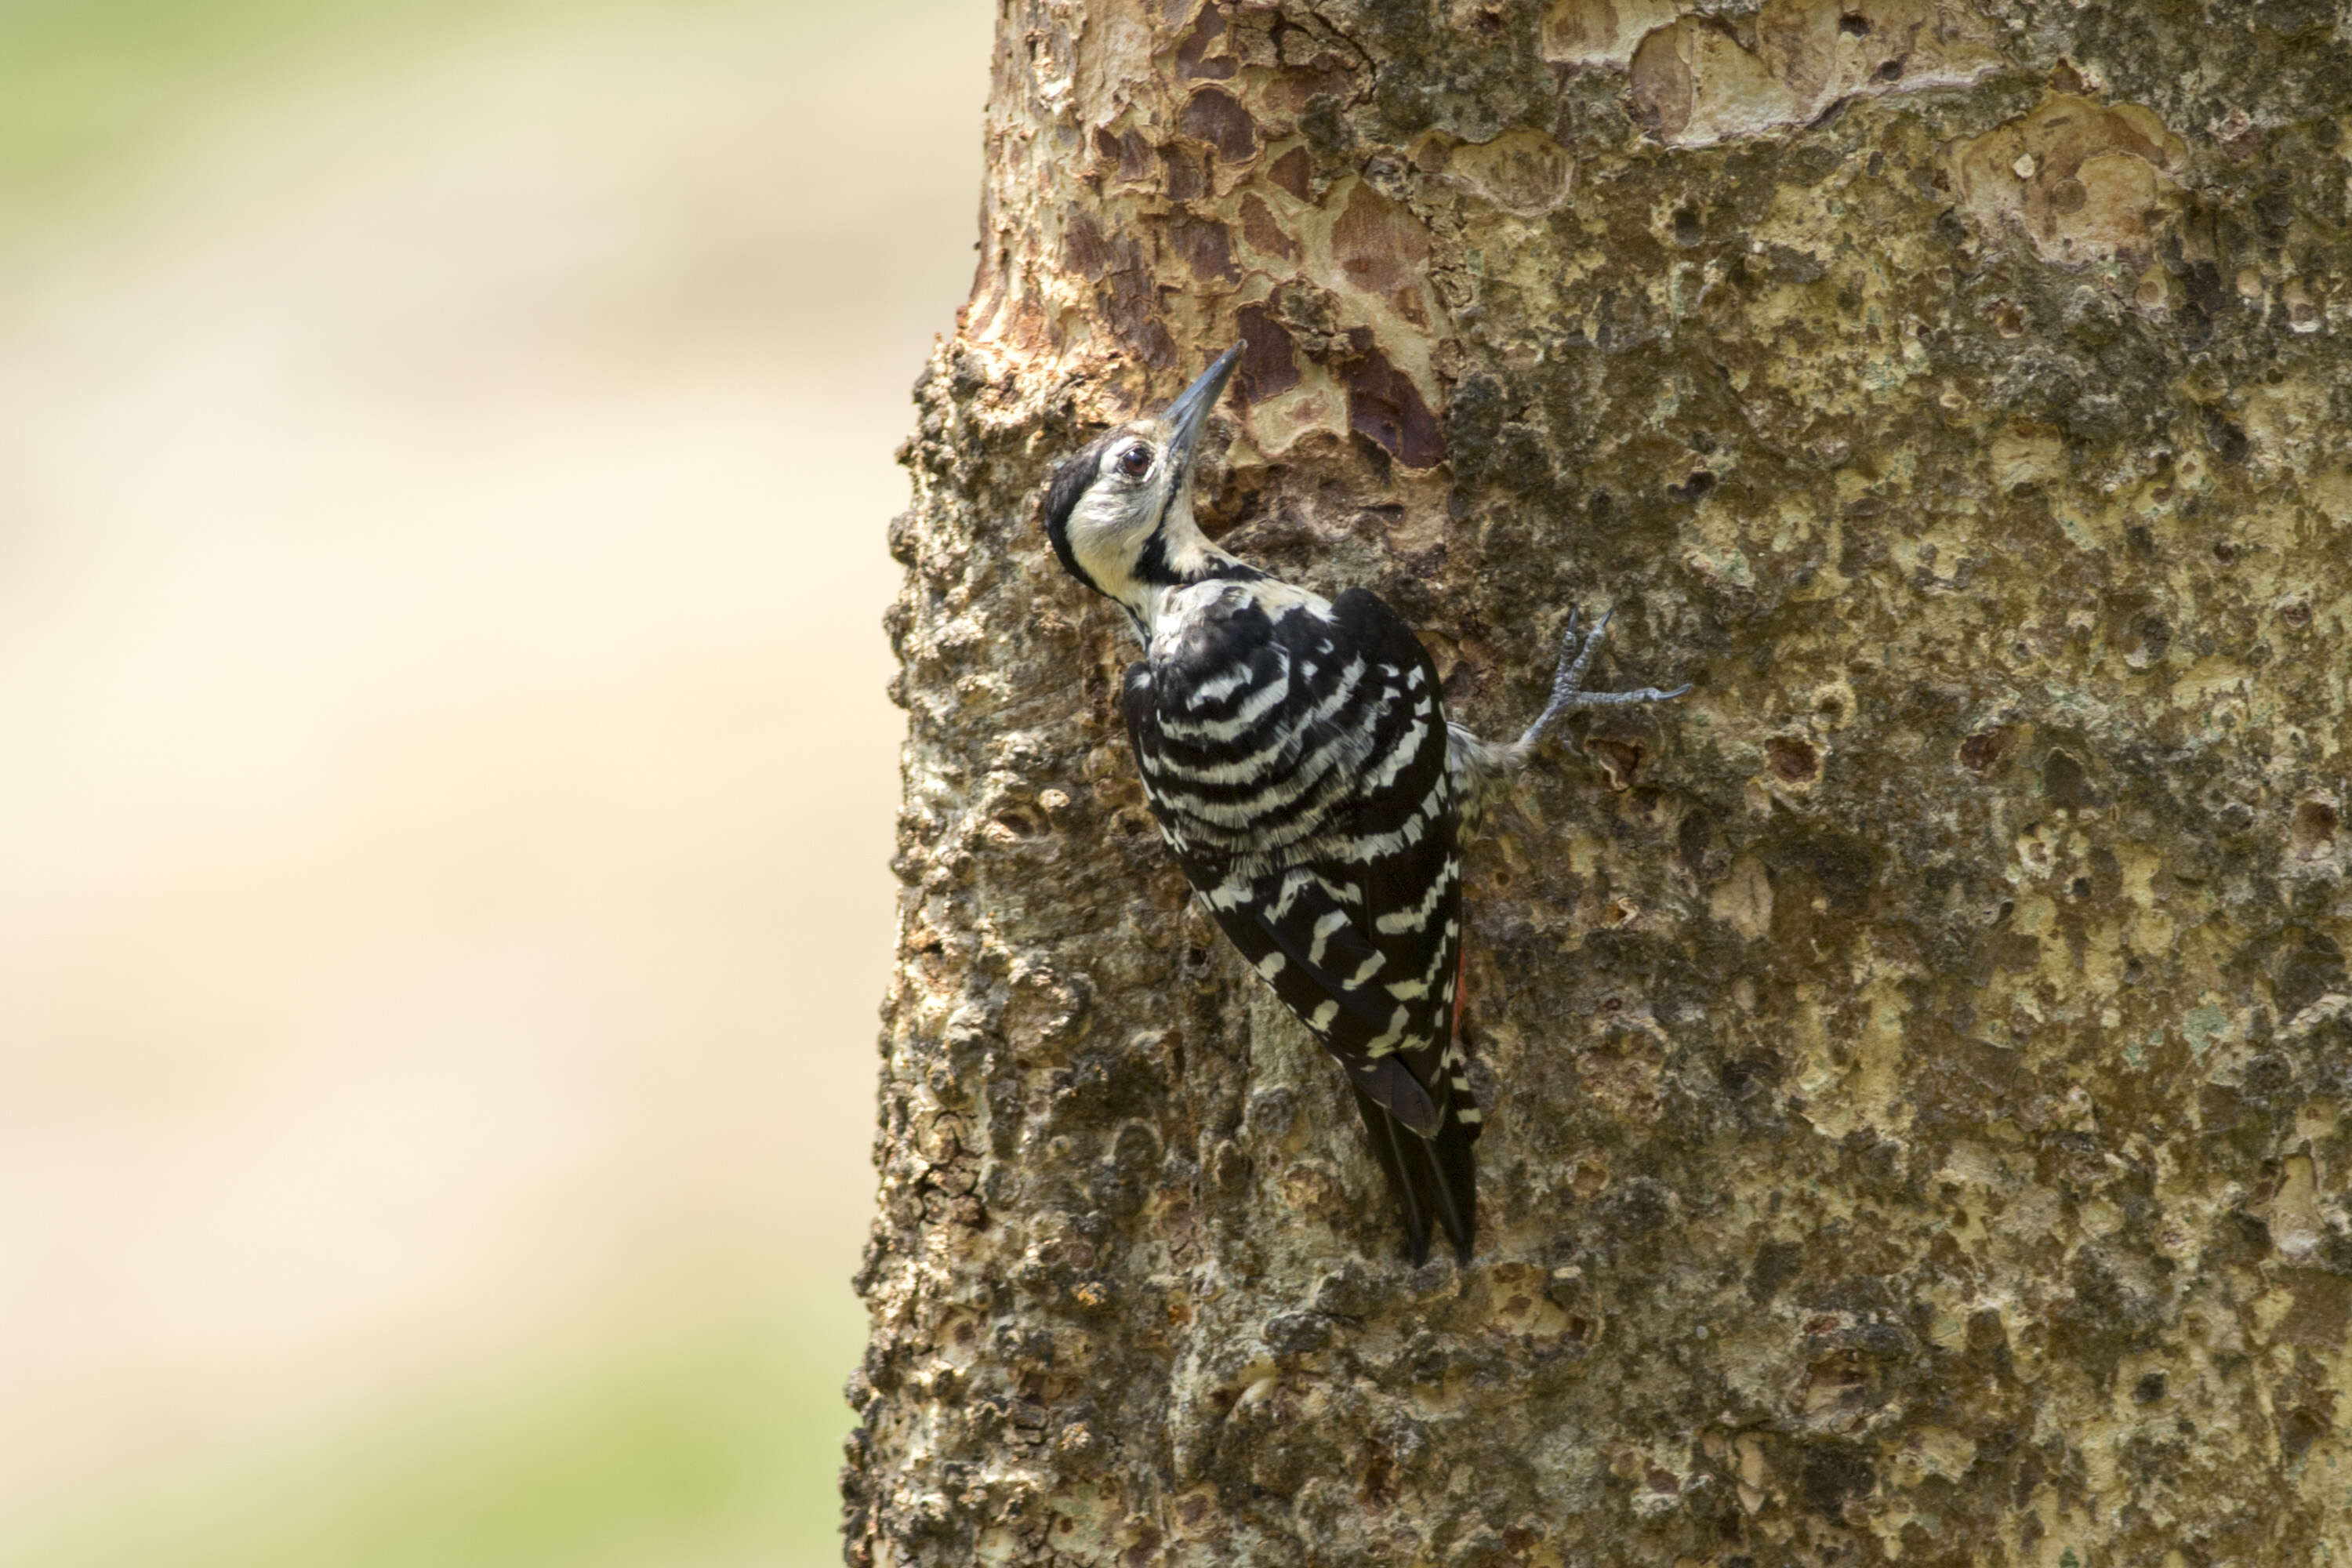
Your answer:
1950,94 -> 2187,266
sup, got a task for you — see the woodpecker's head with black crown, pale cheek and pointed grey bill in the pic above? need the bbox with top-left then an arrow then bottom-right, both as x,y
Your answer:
1044,343 -> 1244,633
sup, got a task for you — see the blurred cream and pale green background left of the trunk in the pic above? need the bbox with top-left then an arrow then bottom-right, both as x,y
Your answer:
0,0 -> 990,1568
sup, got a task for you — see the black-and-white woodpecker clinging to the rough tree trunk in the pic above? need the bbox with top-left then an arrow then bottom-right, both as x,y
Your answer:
1044,343 -> 1689,1265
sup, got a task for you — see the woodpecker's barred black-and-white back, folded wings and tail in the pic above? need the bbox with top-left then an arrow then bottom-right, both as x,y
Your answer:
1127,581 -> 1479,1260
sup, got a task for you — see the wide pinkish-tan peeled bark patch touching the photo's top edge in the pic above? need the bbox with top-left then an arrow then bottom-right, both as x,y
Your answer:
1628,0 -> 2002,146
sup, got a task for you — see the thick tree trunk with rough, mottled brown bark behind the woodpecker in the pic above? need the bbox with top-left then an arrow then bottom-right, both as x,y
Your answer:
847,0 -> 2352,1568
